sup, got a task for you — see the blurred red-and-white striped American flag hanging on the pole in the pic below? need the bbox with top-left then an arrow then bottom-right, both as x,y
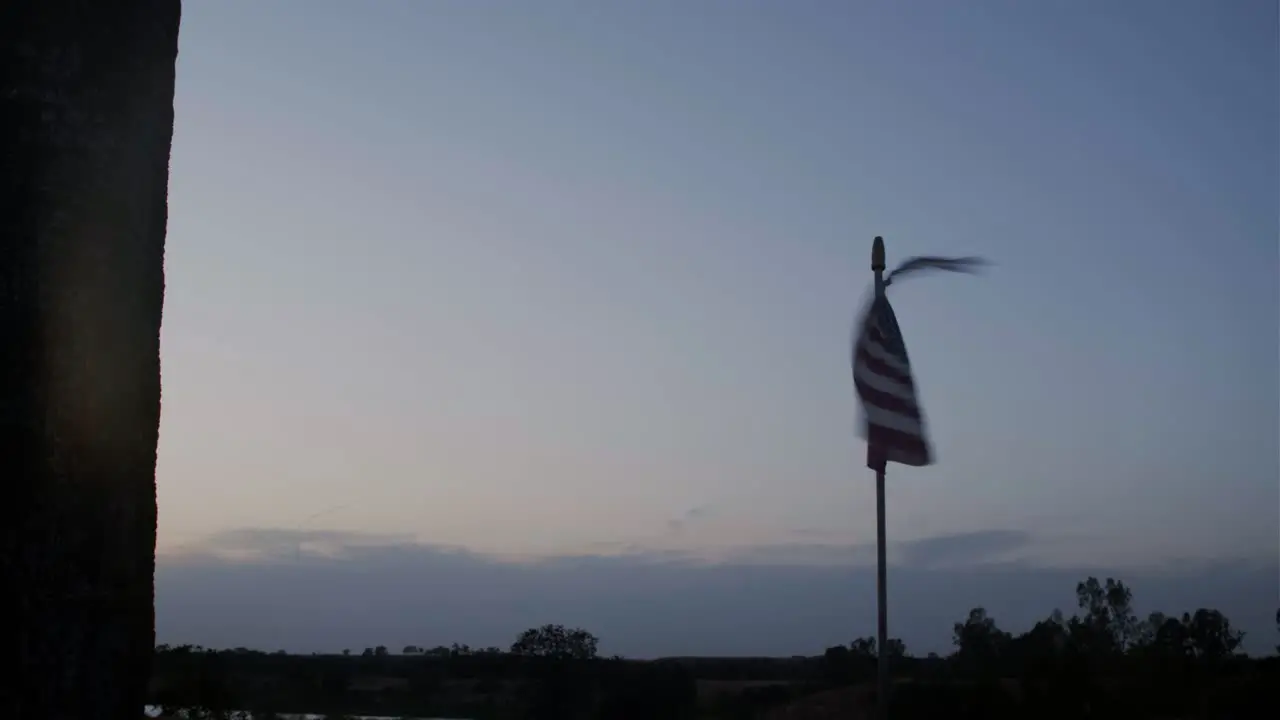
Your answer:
852,293 -> 933,471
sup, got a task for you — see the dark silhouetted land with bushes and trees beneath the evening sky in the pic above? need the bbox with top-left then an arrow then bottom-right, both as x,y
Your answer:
152,577 -> 1280,720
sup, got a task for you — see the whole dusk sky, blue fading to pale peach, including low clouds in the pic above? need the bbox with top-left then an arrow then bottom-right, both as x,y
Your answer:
156,0 -> 1280,655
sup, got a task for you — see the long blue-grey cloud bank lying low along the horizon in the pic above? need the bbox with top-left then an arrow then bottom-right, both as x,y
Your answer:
156,529 -> 1277,657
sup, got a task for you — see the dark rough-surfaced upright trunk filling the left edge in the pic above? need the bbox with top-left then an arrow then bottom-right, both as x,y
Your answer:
0,0 -> 180,720
